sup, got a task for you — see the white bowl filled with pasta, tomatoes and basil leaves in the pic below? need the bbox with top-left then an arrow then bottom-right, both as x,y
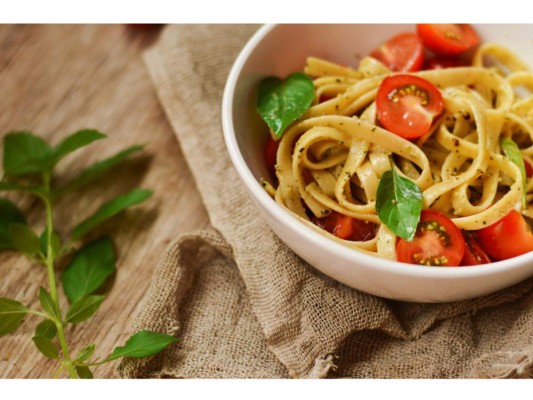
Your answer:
223,24 -> 533,301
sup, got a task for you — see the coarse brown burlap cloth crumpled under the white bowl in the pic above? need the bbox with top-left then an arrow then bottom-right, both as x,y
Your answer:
117,25 -> 533,378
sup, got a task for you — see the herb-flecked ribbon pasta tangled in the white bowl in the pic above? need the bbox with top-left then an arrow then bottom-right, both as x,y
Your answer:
266,44 -> 533,259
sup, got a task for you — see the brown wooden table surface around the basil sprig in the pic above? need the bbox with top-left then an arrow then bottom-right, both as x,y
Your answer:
0,25 -> 209,378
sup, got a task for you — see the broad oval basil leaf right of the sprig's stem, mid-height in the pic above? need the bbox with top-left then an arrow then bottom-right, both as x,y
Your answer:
61,236 -> 116,303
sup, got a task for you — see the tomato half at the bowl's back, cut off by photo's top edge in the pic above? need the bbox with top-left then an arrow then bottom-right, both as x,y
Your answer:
416,24 -> 479,55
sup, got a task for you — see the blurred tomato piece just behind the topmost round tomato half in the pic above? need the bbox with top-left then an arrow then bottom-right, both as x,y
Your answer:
370,32 -> 424,72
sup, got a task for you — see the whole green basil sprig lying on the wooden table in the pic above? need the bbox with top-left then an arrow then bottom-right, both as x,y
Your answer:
0,129 -> 177,378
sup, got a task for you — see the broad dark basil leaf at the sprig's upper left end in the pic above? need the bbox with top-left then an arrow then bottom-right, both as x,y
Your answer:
4,132 -> 54,176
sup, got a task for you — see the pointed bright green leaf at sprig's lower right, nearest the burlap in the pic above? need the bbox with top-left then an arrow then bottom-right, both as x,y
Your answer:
106,331 -> 178,361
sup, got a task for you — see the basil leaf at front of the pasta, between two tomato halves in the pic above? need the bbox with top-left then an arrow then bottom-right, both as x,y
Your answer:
376,169 -> 422,241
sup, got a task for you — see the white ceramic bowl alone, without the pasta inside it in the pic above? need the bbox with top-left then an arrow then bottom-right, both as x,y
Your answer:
222,24 -> 533,302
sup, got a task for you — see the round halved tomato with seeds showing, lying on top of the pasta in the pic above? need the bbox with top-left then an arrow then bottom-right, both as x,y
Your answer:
376,74 -> 444,139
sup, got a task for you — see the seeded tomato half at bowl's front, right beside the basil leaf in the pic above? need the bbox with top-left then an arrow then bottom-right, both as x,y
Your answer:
396,210 -> 465,266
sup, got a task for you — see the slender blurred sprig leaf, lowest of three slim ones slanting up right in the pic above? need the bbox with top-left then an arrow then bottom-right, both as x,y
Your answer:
72,189 -> 153,240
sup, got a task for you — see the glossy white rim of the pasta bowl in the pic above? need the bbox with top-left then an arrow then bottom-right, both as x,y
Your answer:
221,24 -> 533,279
